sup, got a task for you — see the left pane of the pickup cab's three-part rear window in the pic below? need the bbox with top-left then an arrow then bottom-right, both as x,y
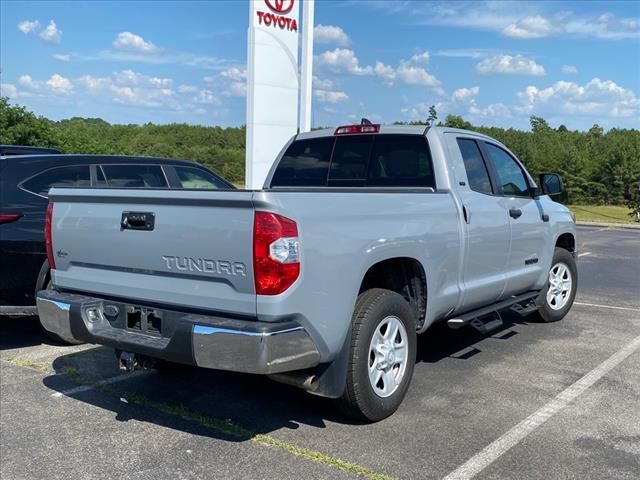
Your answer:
271,137 -> 334,187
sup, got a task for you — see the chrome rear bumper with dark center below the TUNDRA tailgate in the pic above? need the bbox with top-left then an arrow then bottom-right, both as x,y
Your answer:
37,290 -> 320,374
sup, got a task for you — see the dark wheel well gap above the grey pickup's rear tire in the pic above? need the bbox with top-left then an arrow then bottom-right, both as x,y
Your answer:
358,257 -> 427,328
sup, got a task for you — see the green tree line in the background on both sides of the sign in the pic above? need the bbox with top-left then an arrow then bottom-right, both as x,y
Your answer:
0,97 -> 640,209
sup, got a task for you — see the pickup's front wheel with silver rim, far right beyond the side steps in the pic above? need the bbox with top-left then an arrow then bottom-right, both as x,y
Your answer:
538,248 -> 578,322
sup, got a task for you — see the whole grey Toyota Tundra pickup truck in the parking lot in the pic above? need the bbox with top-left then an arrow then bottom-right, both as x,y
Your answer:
38,124 -> 577,421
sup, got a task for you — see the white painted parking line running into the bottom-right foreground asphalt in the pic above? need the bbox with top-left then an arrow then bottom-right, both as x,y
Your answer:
444,336 -> 640,480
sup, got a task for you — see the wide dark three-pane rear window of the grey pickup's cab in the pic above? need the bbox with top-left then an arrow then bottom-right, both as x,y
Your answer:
271,133 -> 436,188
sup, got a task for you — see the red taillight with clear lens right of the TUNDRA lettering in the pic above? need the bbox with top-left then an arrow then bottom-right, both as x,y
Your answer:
253,212 -> 300,295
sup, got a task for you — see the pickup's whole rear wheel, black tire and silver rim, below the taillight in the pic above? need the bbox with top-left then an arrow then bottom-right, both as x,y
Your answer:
340,288 -> 417,421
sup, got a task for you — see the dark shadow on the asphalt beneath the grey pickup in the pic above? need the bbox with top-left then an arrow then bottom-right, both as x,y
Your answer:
43,310 -> 536,441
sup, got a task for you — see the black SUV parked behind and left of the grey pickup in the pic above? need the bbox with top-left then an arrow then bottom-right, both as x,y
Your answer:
0,154 -> 235,313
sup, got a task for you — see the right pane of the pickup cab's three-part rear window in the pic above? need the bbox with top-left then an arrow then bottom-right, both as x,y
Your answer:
367,135 -> 436,188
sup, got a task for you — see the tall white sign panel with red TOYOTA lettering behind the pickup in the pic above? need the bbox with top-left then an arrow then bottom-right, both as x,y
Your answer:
245,0 -> 299,189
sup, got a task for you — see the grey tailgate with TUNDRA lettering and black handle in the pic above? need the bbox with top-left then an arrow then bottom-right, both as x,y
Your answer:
49,188 -> 256,316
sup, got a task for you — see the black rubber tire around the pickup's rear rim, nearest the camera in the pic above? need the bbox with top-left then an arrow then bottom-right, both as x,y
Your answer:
339,288 -> 417,422
